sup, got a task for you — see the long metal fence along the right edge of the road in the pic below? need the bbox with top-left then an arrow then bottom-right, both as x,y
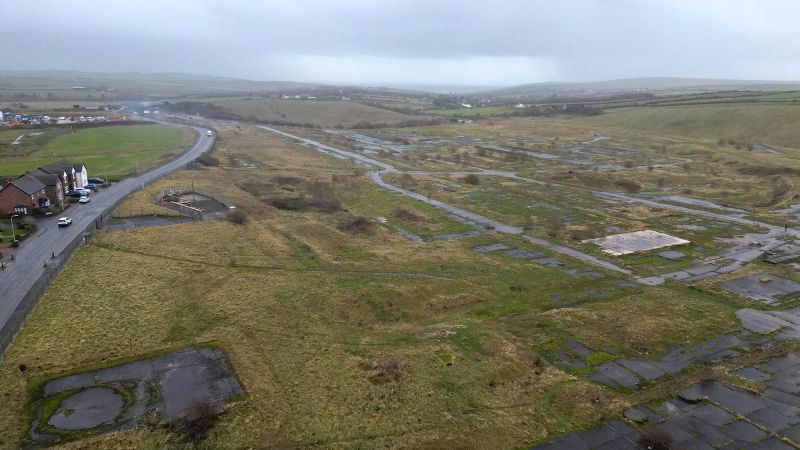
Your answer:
0,124 -> 213,361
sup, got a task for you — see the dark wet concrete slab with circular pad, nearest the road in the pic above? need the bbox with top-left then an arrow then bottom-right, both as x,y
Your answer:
28,347 -> 243,443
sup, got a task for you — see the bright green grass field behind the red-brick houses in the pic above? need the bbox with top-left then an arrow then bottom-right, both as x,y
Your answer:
0,125 -> 194,180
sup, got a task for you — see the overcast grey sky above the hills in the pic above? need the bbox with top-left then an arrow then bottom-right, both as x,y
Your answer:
0,0 -> 800,86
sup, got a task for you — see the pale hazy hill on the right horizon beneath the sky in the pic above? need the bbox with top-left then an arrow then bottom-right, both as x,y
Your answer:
475,78 -> 800,100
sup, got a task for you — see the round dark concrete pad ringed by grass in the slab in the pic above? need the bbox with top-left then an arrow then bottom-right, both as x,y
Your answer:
49,388 -> 124,431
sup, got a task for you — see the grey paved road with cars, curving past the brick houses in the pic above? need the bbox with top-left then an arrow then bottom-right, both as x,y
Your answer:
0,122 -> 214,338
